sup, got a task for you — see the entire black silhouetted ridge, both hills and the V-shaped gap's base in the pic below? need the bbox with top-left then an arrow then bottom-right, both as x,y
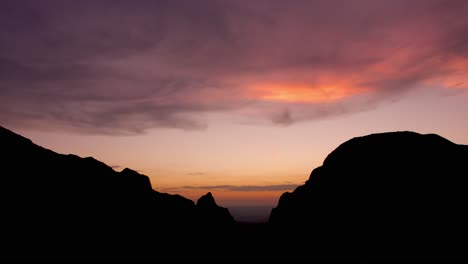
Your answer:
0,127 -> 468,262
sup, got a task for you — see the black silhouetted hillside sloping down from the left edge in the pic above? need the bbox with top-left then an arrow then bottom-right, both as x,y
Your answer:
0,127 -> 232,257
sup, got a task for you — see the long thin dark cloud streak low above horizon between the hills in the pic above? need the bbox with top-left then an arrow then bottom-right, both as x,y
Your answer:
165,184 -> 299,192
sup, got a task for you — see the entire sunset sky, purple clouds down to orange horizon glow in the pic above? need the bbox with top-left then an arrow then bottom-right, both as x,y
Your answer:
0,0 -> 468,219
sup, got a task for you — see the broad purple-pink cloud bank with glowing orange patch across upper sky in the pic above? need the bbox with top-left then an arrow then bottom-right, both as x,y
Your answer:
0,0 -> 468,134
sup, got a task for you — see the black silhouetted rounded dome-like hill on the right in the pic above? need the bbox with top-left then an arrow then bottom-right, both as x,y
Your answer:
270,132 -> 468,257
